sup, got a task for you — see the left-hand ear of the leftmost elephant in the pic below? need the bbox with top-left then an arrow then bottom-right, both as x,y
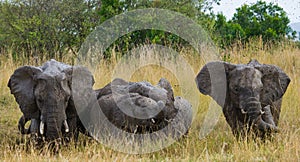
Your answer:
7,66 -> 42,119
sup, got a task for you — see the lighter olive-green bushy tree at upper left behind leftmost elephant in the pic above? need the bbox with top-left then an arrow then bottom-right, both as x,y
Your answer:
0,0 -> 99,60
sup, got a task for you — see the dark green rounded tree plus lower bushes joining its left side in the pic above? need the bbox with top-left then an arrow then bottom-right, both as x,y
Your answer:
215,1 -> 296,47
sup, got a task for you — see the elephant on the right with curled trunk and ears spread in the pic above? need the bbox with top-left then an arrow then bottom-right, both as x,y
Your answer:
195,60 -> 291,138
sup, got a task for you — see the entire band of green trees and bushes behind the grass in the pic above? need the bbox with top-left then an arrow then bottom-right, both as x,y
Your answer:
0,0 -> 295,60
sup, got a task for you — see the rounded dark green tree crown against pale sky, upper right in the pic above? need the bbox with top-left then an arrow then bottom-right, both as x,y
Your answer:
232,1 -> 295,41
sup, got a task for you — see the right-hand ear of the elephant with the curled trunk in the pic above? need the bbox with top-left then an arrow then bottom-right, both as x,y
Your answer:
254,63 -> 291,105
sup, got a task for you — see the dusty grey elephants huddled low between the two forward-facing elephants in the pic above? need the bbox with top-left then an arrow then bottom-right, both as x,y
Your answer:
91,78 -> 192,136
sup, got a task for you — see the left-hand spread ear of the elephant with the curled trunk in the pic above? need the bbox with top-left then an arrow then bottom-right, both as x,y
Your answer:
195,61 -> 236,107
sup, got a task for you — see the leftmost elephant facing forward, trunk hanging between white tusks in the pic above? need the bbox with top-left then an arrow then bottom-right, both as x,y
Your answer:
8,59 -> 94,141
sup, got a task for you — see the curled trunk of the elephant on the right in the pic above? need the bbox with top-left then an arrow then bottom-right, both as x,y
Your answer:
242,98 -> 278,132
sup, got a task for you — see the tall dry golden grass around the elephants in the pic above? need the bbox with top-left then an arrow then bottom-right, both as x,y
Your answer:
0,41 -> 300,161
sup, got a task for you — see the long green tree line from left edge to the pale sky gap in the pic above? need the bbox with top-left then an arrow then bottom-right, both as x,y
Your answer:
0,0 -> 220,60
